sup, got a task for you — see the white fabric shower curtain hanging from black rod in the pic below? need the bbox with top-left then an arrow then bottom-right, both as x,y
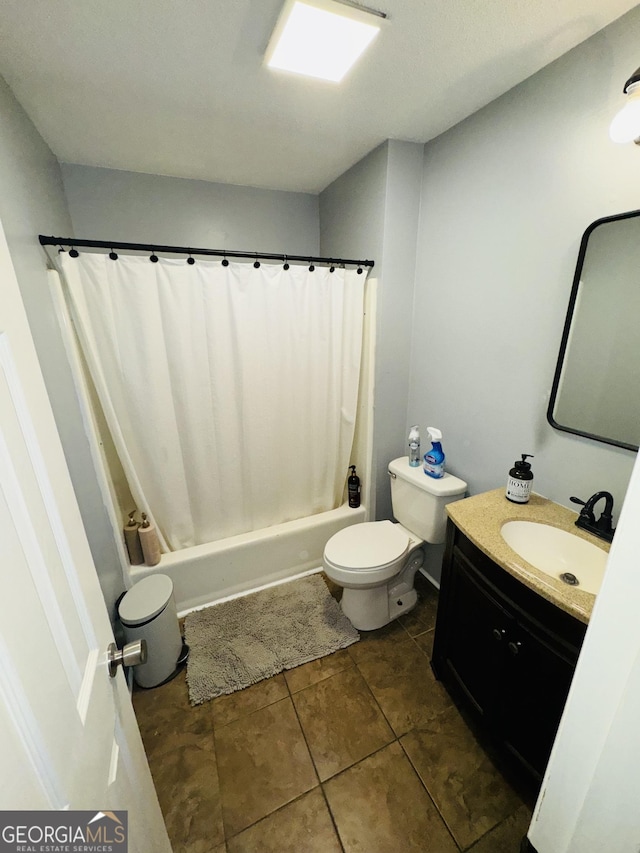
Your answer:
60,252 -> 366,550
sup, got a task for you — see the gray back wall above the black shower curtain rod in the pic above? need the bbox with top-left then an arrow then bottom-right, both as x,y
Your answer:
56,163 -> 318,255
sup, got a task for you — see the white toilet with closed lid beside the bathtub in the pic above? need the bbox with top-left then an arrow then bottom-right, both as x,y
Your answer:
323,456 -> 467,631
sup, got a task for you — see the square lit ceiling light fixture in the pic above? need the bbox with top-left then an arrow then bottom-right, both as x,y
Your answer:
265,0 -> 387,83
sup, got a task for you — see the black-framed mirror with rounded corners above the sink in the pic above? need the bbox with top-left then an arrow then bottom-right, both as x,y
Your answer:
547,210 -> 640,451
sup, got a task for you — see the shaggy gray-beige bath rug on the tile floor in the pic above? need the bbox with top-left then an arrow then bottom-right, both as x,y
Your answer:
184,575 -> 360,705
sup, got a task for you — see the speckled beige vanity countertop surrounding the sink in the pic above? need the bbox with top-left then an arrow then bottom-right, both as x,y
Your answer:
447,489 -> 609,622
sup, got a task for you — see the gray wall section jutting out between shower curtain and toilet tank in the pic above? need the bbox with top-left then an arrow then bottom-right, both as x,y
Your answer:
320,140 -> 423,518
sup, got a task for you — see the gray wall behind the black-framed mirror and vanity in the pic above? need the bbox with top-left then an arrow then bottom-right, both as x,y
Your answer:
409,9 -> 640,552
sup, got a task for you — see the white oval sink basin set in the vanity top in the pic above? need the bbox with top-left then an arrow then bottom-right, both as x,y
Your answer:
500,521 -> 609,595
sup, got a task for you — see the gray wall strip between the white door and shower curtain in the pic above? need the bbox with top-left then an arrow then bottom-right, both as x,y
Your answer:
0,73 -> 127,607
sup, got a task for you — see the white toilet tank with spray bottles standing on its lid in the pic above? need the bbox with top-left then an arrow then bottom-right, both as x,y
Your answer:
389,456 -> 467,545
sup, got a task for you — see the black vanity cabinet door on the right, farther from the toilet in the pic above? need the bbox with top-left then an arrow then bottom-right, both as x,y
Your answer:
499,624 -> 576,780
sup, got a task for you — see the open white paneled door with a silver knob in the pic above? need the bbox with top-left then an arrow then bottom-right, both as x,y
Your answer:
0,224 -> 171,853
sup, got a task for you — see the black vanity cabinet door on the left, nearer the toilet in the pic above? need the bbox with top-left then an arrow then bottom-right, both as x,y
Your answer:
441,551 -> 515,721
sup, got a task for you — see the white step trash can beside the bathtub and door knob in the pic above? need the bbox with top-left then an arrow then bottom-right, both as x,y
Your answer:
118,575 -> 185,687
